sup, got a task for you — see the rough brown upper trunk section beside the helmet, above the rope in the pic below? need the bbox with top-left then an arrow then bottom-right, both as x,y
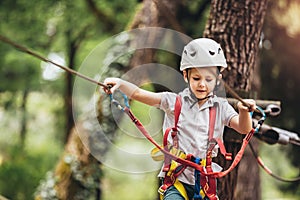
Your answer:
204,0 -> 267,91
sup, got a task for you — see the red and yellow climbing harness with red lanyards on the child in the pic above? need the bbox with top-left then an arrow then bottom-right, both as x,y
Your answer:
110,91 -> 266,200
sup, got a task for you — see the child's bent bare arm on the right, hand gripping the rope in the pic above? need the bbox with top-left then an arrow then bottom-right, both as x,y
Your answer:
230,99 -> 255,134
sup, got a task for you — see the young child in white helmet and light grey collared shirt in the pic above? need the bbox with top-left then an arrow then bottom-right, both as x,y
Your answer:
104,38 -> 255,200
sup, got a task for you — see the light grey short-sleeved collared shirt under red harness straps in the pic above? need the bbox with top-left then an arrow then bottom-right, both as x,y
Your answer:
159,88 -> 238,184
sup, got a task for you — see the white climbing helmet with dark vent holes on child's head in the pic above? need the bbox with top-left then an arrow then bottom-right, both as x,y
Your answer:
180,38 -> 227,71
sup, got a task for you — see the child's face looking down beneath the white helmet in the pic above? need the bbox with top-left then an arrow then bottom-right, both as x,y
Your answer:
183,67 -> 221,99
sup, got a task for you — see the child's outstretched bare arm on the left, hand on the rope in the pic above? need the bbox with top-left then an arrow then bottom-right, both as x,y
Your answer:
104,78 -> 161,106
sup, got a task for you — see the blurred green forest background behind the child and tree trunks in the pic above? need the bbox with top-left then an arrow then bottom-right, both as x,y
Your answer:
0,0 -> 300,200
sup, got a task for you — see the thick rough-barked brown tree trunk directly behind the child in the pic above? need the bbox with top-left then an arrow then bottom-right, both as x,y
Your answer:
204,0 -> 267,200
